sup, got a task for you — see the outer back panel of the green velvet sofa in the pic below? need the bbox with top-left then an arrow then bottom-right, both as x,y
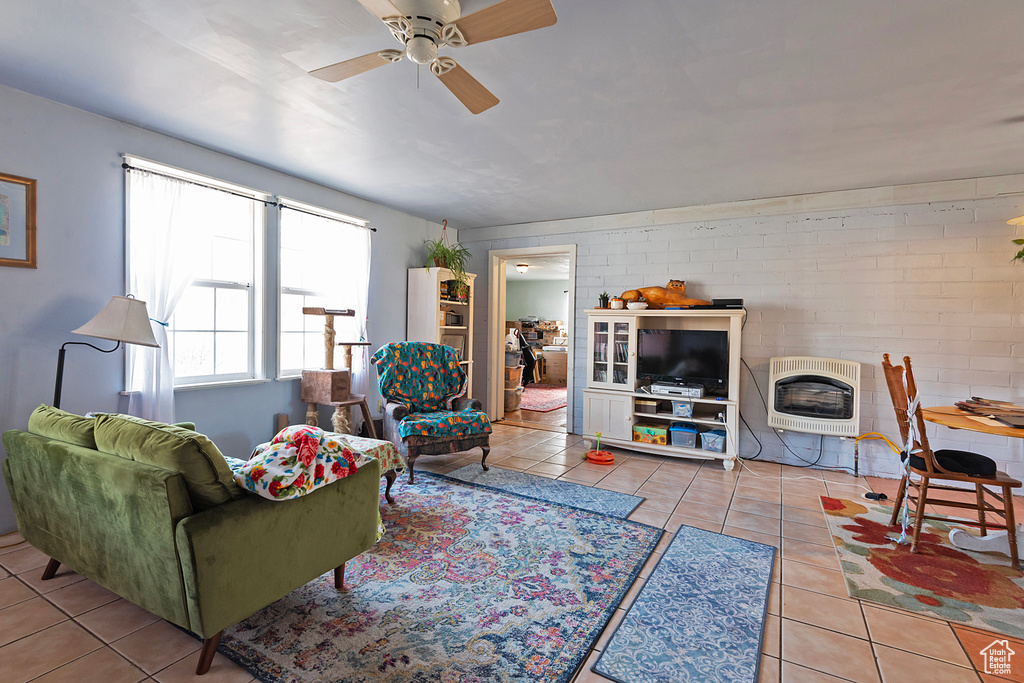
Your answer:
3,430 -> 191,628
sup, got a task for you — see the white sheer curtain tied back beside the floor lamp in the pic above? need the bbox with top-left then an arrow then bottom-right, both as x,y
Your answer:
126,169 -> 198,422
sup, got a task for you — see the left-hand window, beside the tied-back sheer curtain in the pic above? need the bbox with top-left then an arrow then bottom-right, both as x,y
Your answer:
128,159 -> 267,387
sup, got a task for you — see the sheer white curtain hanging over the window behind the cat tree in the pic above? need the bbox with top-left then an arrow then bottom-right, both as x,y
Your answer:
281,205 -> 371,419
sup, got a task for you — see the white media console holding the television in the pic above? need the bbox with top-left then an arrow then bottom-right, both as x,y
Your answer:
583,308 -> 746,470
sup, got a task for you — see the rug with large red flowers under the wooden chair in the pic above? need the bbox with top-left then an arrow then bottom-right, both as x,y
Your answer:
821,496 -> 1024,638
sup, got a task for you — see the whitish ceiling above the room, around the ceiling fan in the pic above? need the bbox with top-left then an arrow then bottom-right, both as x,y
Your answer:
0,0 -> 1024,227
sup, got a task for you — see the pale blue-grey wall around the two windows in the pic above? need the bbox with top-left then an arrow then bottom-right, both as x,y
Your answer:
0,86 -> 439,533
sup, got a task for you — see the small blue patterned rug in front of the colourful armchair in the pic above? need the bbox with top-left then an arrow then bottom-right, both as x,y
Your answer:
439,465 -> 644,519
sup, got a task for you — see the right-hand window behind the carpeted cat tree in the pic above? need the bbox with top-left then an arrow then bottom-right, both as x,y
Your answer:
278,199 -> 370,384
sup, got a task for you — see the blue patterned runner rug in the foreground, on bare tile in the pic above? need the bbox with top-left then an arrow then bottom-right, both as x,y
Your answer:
592,526 -> 775,683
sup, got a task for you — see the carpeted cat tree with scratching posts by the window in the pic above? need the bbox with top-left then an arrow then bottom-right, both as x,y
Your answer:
302,306 -> 377,438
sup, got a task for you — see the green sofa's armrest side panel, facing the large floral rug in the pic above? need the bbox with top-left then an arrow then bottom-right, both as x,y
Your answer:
176,460 -> 381,638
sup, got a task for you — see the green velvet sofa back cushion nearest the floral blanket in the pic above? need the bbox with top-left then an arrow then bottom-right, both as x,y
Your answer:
96,415 -> 245,510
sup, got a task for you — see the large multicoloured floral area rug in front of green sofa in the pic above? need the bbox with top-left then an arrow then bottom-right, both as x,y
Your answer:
220,472 -> 663,683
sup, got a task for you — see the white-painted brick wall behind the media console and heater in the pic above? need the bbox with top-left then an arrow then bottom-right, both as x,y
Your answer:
460,192 -> 1024,476
